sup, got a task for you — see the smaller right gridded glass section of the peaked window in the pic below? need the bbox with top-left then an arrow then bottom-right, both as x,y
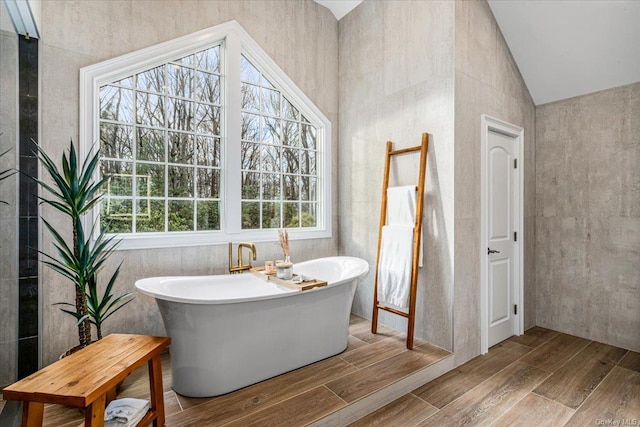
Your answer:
240,55 -> 318,229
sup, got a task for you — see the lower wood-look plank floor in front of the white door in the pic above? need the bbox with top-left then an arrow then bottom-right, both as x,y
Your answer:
351,327 -> 640,427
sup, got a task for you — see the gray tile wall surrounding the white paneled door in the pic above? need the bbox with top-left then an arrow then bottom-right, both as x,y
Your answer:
454,1 -> 536,364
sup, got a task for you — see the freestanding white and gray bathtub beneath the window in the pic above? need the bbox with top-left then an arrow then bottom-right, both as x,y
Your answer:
136,256 -> 369,397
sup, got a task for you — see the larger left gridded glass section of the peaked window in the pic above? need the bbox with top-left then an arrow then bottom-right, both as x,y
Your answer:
99,46 -> 222,233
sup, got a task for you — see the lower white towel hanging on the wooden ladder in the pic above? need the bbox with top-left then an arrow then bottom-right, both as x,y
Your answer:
378,225 -> 413,309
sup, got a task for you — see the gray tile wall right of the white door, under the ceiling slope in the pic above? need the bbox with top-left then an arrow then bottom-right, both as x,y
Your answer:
536,83 -> 640,351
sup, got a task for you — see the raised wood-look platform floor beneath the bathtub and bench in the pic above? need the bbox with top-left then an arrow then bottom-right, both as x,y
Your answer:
30,315 -> 451,427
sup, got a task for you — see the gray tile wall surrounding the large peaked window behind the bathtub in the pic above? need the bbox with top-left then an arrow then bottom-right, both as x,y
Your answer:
38,0 -> 338,364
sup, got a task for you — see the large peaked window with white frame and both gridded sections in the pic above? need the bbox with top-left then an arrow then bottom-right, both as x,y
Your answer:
81,22 -> 331,248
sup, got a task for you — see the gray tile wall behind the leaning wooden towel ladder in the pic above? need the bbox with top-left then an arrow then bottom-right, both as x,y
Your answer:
338,1 -> 454,350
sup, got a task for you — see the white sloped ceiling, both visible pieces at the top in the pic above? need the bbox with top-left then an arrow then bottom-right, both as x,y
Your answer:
315,0 -> 640,105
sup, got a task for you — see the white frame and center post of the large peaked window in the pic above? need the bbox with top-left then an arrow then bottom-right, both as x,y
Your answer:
79,21 -> 331,249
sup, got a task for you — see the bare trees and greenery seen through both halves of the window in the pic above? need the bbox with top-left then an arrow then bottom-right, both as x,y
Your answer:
99,45 -> 319,237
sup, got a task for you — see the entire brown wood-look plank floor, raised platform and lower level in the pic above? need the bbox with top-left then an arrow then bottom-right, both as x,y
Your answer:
6,322 -> 640,427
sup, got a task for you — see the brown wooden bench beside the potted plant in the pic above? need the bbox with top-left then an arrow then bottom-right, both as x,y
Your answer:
2,334 -> 171,427
